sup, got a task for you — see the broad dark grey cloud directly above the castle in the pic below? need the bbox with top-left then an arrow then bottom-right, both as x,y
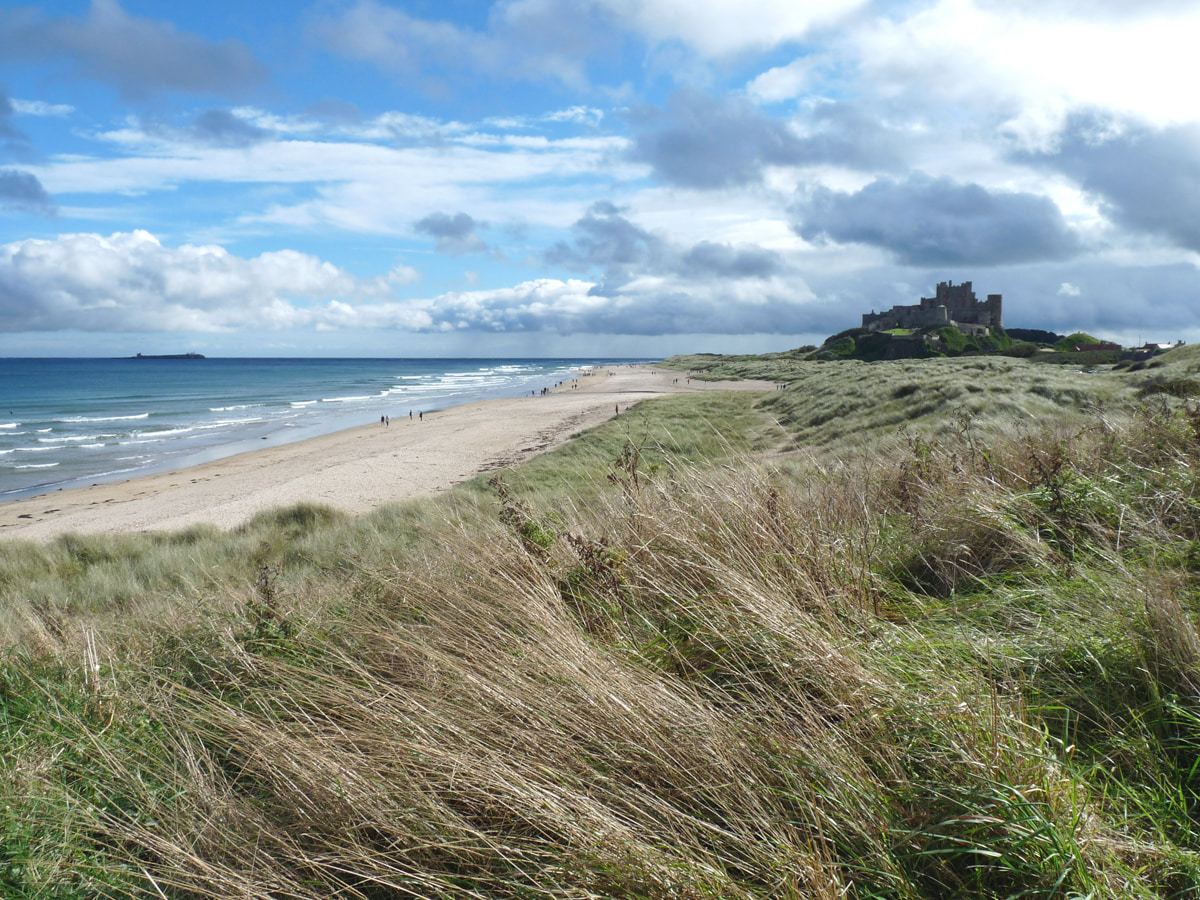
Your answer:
791,173 -> 1080,265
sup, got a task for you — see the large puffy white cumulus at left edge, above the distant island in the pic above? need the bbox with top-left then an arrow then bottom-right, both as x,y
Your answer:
0,232 -> 374,331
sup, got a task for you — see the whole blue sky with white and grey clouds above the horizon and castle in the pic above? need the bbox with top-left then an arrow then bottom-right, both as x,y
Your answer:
0,0 -> 1200,358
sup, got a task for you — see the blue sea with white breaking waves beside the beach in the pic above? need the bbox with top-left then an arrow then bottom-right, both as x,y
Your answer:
0,359 -> 640,502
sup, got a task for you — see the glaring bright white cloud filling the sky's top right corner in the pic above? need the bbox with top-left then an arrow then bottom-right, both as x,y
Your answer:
851,0 -> 1200,144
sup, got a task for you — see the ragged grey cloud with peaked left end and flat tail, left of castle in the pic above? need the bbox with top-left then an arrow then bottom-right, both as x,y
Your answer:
544,200 -> 784,296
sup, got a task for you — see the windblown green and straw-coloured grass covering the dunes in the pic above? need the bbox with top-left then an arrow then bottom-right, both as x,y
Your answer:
7,348 -> 1200,900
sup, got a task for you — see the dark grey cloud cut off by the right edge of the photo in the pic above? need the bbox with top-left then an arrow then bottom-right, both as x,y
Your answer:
1024,115 -> 1200,251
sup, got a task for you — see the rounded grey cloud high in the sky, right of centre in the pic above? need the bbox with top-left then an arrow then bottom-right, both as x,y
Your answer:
630,89 -> 811,188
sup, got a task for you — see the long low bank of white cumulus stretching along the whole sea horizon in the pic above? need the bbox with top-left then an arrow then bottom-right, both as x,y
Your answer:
0,232 -> 824,336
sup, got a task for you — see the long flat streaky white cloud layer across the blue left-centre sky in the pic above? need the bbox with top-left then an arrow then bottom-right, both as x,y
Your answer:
39,126 -> 638,240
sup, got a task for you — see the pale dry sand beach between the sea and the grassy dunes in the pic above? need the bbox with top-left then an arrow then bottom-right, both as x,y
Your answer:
0,366 -> 770,540
